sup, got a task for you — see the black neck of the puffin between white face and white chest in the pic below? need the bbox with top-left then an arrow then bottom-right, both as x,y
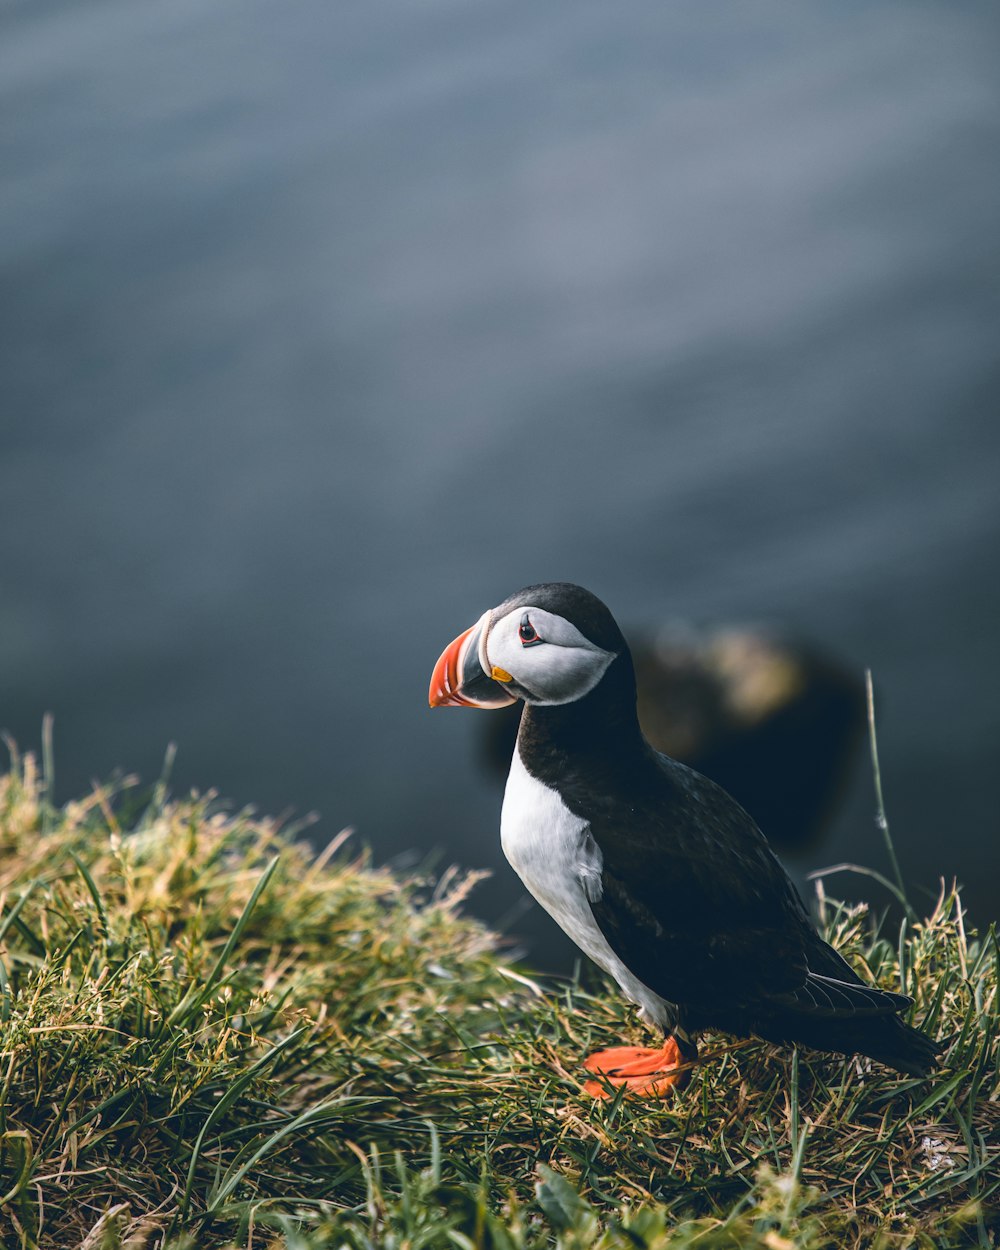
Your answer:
518,651 -> 646,776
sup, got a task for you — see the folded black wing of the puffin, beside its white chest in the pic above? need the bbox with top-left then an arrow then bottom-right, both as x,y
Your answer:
588,754 -> 909,1028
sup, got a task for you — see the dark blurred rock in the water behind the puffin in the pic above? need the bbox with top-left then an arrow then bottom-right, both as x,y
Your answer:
479,626 -> 865,850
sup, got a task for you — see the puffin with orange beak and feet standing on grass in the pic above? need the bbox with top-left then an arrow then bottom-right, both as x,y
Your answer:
429,581 -> 941,1098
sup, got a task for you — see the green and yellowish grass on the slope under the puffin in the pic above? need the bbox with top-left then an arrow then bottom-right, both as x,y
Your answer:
0,758 -> 1000,1250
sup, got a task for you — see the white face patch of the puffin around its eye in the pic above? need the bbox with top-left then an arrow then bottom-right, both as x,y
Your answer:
479,604 -> 615,704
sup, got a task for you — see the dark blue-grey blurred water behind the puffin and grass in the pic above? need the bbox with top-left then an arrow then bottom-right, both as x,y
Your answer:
0,0 -> 1000,960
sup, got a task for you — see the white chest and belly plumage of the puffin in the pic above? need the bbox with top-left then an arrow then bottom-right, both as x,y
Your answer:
500,749 -> 673,1029
